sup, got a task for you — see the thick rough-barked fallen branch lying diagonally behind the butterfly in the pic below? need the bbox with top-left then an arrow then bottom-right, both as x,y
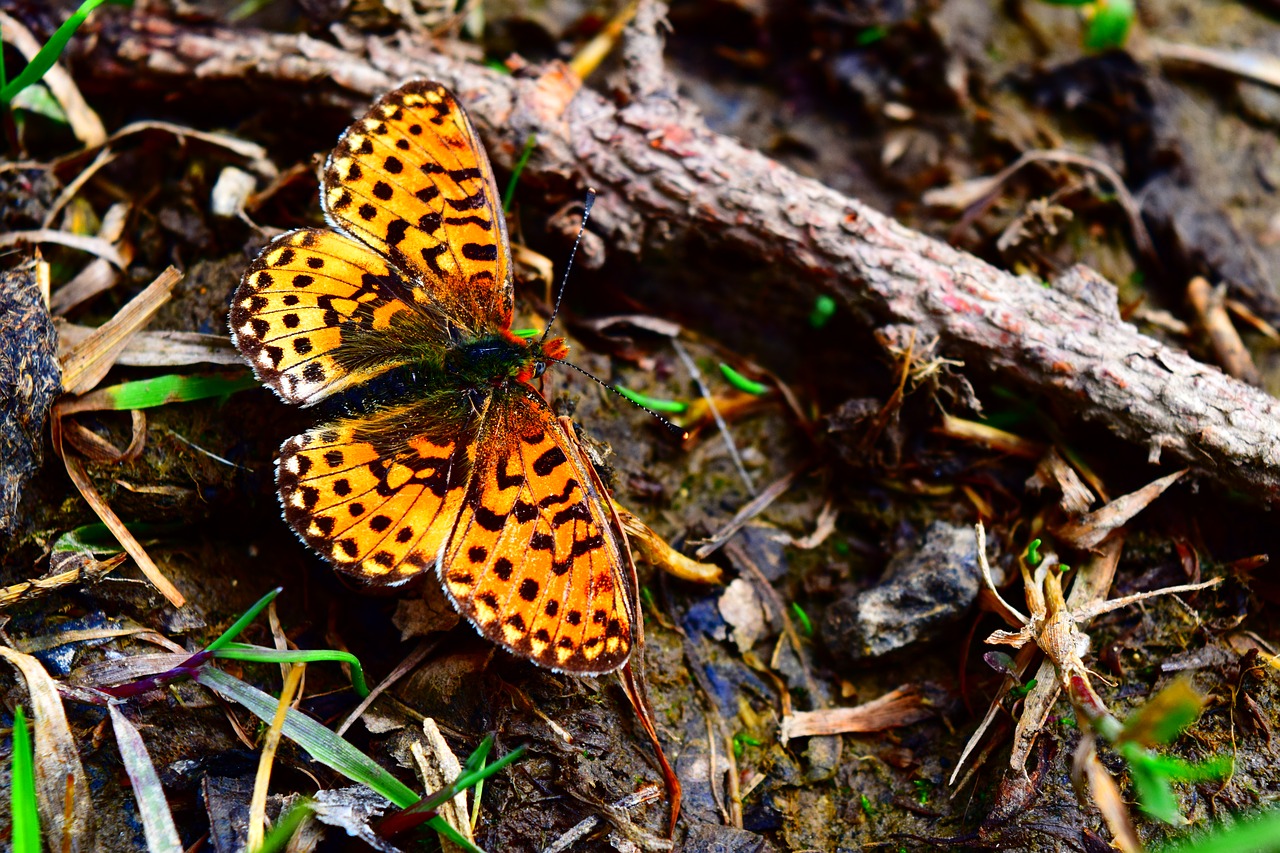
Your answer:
67,3 -> 1280,502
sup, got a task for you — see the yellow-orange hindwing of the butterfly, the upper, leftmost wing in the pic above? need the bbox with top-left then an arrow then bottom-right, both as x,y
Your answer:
230,228 -> 422,405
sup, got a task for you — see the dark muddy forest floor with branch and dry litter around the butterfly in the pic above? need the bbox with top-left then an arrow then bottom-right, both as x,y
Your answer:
0,0 -> 1280,853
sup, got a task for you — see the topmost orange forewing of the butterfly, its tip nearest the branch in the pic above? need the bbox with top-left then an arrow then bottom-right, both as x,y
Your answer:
321,81 -> 512,332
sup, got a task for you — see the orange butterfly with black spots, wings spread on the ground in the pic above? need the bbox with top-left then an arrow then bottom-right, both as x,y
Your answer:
229,81 -> 639,675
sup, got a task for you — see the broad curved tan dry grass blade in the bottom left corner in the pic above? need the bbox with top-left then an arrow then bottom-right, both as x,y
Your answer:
0,646 -> 95,853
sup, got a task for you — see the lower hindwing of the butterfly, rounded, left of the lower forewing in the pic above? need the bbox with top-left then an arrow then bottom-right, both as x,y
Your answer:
276,405 -> 475,587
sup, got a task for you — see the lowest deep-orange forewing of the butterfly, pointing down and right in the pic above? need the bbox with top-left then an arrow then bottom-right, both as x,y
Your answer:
439,389 -> 637,675
